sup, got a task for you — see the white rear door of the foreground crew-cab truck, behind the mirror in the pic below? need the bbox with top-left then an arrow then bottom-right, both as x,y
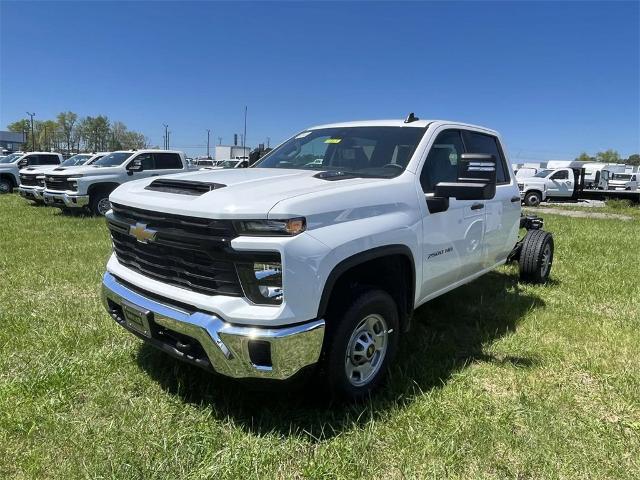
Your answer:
463,130 -> 521,269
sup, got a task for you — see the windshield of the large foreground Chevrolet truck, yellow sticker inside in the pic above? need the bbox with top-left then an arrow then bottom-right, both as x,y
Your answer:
254,127 -> 425,178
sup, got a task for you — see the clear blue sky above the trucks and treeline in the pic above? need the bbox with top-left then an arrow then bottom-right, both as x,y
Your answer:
0,1 -> 640,160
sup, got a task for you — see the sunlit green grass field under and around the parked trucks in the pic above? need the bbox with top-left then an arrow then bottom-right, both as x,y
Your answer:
0,195 -> 640,479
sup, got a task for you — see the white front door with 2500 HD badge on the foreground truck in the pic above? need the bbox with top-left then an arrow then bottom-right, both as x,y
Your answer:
420,127 -> 485,299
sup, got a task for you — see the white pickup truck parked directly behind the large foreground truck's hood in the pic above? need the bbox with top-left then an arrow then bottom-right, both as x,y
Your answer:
43,150 -> 188,215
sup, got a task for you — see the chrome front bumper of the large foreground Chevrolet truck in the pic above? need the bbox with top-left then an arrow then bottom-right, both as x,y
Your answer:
102,272 -> 325,380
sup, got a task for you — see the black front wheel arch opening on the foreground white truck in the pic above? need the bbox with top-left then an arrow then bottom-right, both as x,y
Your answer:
317,245 -> 416,330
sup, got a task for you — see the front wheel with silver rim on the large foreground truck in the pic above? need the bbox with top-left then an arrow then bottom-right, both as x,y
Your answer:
325,289 -> 399,400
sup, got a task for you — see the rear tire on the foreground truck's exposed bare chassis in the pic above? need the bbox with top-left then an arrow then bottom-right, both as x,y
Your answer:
519,230 -> 553,283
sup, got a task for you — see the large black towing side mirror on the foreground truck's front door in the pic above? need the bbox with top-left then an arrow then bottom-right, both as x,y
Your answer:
434,153 -> 496,200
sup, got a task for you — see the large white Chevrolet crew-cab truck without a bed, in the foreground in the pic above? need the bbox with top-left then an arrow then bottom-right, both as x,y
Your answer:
102,118 -> 553,399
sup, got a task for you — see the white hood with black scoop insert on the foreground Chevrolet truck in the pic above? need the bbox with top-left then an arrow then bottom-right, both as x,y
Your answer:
109,168 -> 389,219
